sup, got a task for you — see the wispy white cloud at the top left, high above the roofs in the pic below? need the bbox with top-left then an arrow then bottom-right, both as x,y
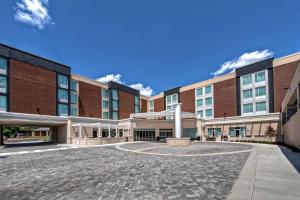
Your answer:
15,0 -> 54,29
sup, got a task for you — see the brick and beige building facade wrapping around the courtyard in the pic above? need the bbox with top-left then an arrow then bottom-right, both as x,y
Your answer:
0,44 -> 300,148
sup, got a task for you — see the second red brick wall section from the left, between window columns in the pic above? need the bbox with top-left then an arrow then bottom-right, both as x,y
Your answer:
78,81 -> 102,118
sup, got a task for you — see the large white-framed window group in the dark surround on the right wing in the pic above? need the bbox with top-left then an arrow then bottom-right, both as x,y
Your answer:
240,70 -> 269,116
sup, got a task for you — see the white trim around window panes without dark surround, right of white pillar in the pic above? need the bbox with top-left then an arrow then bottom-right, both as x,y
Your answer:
195,84 -> 215,119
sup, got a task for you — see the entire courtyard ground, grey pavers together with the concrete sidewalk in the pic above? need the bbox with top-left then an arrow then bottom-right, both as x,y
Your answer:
0,142 -> 300,200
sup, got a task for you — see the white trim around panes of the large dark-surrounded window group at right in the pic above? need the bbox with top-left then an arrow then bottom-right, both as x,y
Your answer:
240,69 -> 269,116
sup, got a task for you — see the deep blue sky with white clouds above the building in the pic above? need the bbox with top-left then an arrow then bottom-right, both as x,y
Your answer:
0,0 -> 300,94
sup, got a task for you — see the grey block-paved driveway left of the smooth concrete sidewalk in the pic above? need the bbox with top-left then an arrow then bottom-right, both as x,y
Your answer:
0,143 -> 249,200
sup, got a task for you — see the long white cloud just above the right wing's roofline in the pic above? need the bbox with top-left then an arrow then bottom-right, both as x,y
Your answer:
212,49 -> 274,76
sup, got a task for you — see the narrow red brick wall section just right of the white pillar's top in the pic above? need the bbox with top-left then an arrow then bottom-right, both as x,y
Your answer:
179,89 -> 195,113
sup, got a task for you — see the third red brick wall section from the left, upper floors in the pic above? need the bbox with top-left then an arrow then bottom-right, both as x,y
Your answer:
119,91 -> 134,119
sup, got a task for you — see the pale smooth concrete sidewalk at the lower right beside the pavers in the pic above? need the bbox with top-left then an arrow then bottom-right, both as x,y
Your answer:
228,144 -> 300,200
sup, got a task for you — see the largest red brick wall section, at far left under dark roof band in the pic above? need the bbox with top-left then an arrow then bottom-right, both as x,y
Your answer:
10,59 -> 56,115
